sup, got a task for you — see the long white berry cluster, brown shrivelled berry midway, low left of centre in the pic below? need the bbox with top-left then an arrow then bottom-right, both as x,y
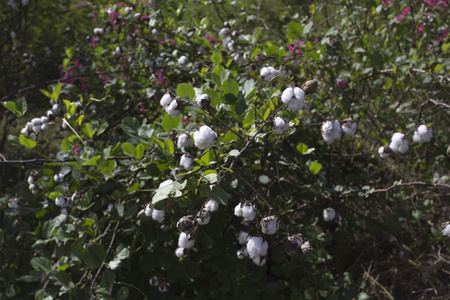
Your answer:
175,199 -> 219,258
